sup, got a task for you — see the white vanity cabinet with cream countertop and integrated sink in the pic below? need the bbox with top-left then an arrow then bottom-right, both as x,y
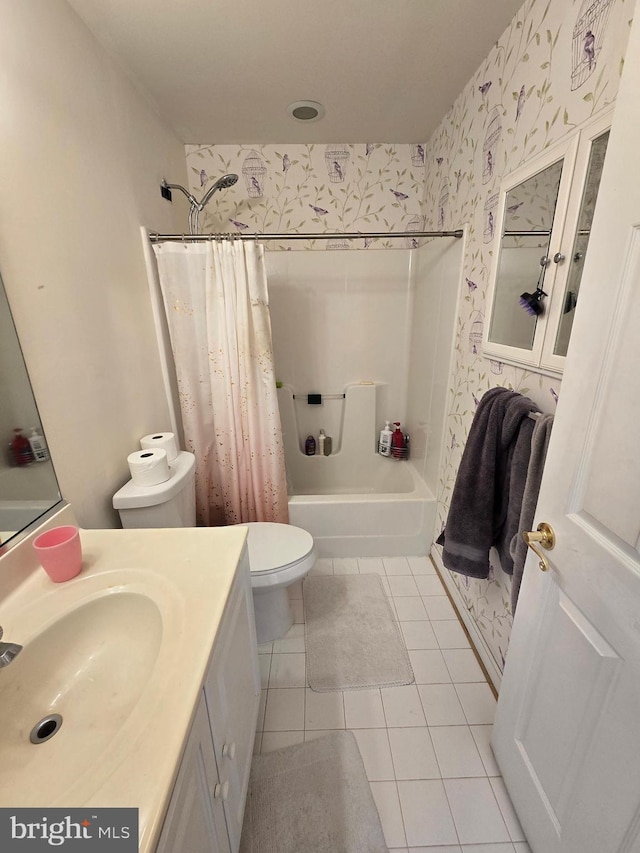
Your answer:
0,508 -> 260,853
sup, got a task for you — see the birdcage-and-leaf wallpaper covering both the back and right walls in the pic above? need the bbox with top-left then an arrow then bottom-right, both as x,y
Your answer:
186,0 -> 634,669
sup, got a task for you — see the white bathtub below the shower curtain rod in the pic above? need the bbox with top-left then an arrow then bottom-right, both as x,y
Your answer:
289,452 -> 436,557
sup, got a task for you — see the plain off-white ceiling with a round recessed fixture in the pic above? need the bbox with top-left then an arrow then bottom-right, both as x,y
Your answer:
68,0 -> 522,144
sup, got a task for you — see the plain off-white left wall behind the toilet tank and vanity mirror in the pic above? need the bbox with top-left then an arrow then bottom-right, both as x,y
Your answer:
0,0 -> 186,527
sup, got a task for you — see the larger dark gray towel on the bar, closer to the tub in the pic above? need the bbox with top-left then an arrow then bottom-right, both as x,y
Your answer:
437,388 -> 536,578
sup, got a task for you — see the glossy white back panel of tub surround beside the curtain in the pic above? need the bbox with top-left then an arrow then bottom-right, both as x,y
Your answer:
266,249 -> 411,450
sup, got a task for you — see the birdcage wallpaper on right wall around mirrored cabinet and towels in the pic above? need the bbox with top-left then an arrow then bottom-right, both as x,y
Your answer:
424,0 -> 634,669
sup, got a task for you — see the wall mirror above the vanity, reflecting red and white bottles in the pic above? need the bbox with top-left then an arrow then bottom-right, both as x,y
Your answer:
0,270 -> 61,546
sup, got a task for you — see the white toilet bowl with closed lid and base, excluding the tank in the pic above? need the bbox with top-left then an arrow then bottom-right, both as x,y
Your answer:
243,521 -> 317,645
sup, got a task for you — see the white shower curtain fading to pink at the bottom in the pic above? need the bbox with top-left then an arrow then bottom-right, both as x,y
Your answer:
154,240 -> 289,527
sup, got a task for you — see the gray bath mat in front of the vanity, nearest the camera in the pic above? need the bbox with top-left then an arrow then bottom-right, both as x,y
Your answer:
240,731 -> 388,853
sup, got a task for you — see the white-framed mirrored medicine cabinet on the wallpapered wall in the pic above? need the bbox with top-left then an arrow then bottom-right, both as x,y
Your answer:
483,111 -> 611,374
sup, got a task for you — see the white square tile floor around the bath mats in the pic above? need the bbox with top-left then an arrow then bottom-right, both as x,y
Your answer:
255,557 -> 530,853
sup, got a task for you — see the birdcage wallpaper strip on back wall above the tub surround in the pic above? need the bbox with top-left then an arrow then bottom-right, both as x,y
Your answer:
186,143 -> 425,251
